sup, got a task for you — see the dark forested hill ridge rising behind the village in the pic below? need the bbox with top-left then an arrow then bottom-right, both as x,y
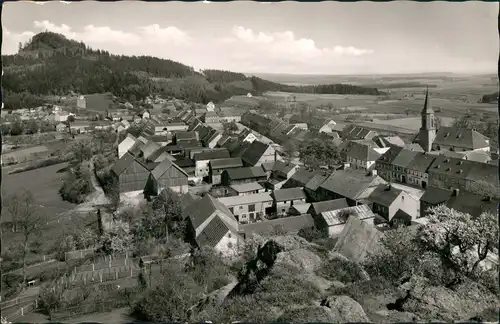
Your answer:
2,32 -> 379,109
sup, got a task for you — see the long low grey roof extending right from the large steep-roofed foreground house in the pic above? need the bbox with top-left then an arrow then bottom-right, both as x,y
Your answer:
240,215 -> 314,235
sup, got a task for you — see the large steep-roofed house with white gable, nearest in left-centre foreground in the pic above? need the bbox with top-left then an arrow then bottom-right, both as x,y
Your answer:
186,195 -> 242,256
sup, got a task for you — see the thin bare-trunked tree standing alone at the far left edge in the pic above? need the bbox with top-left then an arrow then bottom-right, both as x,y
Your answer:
7,191 -> 44,283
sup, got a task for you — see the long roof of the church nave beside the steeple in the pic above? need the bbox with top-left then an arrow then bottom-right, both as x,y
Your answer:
433,127 -> 490,150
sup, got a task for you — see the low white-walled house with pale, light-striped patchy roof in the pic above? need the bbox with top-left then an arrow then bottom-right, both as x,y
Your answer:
314,205 -> 375,237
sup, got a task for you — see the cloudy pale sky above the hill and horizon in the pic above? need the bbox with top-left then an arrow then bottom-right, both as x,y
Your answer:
2,1 -> 499,75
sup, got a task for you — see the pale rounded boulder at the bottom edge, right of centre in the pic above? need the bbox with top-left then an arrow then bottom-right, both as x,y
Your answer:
321,296 -> 370,323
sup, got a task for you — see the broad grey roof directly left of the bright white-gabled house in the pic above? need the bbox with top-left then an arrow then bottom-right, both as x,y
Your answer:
320,169 -> 379,200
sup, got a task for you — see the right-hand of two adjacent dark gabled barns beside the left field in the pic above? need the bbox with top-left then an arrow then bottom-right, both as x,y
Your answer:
149,159 -> 189,195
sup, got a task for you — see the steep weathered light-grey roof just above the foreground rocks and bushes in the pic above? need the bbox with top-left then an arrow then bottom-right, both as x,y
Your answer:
333,217 -> 384,262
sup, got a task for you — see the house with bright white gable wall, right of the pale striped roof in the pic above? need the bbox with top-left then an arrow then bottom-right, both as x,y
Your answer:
367,185 -> 420,224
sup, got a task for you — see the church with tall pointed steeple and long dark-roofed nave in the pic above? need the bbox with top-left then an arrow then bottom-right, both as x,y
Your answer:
414,89 -> 490,154
